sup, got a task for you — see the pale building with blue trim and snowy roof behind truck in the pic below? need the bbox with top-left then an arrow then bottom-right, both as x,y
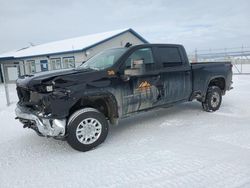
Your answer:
0,29 -> 147,82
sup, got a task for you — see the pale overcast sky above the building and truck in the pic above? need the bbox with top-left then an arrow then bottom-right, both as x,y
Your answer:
0,0 -> 250,53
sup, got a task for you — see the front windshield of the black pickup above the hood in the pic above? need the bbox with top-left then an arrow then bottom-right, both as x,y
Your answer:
77,48 -> 127,70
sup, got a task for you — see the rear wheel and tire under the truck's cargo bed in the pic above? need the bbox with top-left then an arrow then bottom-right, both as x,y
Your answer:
202,86 -> 222,112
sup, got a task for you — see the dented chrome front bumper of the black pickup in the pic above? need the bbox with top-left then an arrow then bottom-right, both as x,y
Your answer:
15,104 -> 66,137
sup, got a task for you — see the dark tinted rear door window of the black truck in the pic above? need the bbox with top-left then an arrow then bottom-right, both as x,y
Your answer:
158,47 -> 182,67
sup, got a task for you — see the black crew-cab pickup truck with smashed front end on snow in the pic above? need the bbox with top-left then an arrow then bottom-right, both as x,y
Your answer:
16,44 -> 232,151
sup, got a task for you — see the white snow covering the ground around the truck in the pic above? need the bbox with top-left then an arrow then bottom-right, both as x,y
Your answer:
0,75 -> 250,188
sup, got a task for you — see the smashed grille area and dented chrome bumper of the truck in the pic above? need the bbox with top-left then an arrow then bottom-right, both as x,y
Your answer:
15,78 -> 69,139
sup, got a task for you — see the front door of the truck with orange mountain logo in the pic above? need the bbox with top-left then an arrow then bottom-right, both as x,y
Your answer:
120,47 -> 163,114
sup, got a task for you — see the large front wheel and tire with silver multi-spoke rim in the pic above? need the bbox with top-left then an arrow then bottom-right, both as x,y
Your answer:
66,108 -> 109,152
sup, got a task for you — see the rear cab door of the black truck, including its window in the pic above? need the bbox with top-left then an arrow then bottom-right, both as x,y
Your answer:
155,45 -> 192,103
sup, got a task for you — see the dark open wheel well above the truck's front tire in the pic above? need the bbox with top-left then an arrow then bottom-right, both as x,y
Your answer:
69,95 -> 118,120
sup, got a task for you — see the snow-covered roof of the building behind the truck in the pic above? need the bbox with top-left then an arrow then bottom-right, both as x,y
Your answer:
0,28 -> 148,59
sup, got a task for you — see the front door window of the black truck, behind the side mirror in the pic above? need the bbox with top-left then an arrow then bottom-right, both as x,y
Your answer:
125,48 -> 155,71
